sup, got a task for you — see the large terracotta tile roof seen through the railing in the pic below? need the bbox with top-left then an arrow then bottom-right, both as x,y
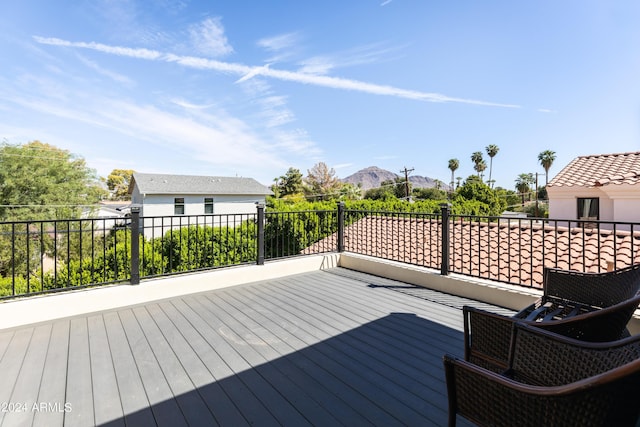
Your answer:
304,216 -> 640,287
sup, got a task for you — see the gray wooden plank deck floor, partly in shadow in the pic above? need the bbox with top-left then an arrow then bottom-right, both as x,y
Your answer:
0,268 -> 510,426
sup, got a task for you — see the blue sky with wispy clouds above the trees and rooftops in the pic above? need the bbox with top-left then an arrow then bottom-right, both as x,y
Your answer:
0,0 -> 640,189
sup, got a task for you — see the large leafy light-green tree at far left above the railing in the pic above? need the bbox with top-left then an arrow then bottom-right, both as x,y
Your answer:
0,141 -> 106,221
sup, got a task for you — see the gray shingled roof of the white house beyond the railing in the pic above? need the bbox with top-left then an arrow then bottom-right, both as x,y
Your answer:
129,172 -> 272,196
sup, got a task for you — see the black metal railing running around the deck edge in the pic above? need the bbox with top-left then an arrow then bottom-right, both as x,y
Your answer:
0,203 -> 640,298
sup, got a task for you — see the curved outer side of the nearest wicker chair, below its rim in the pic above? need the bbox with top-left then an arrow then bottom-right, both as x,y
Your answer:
444,355 -> 640,427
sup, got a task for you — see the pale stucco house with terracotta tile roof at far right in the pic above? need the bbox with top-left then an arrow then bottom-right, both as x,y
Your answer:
547,152 -> 640,227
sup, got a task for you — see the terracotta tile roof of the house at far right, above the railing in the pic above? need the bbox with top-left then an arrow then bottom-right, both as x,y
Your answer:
548,152 -> 640,187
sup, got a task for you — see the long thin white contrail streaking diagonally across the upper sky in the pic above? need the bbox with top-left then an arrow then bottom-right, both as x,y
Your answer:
35,37 -> 520,108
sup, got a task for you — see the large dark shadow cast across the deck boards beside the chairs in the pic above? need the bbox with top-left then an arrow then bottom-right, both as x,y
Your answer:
94,313 -> 464,426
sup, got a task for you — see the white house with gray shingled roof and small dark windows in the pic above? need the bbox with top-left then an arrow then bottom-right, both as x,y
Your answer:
129,172 -> 272,217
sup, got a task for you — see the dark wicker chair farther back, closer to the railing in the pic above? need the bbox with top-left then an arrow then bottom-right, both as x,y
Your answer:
462,265 -> 640,372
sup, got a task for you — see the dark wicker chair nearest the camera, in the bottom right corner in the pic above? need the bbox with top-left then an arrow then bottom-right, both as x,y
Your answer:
444,324 -> 640,426
